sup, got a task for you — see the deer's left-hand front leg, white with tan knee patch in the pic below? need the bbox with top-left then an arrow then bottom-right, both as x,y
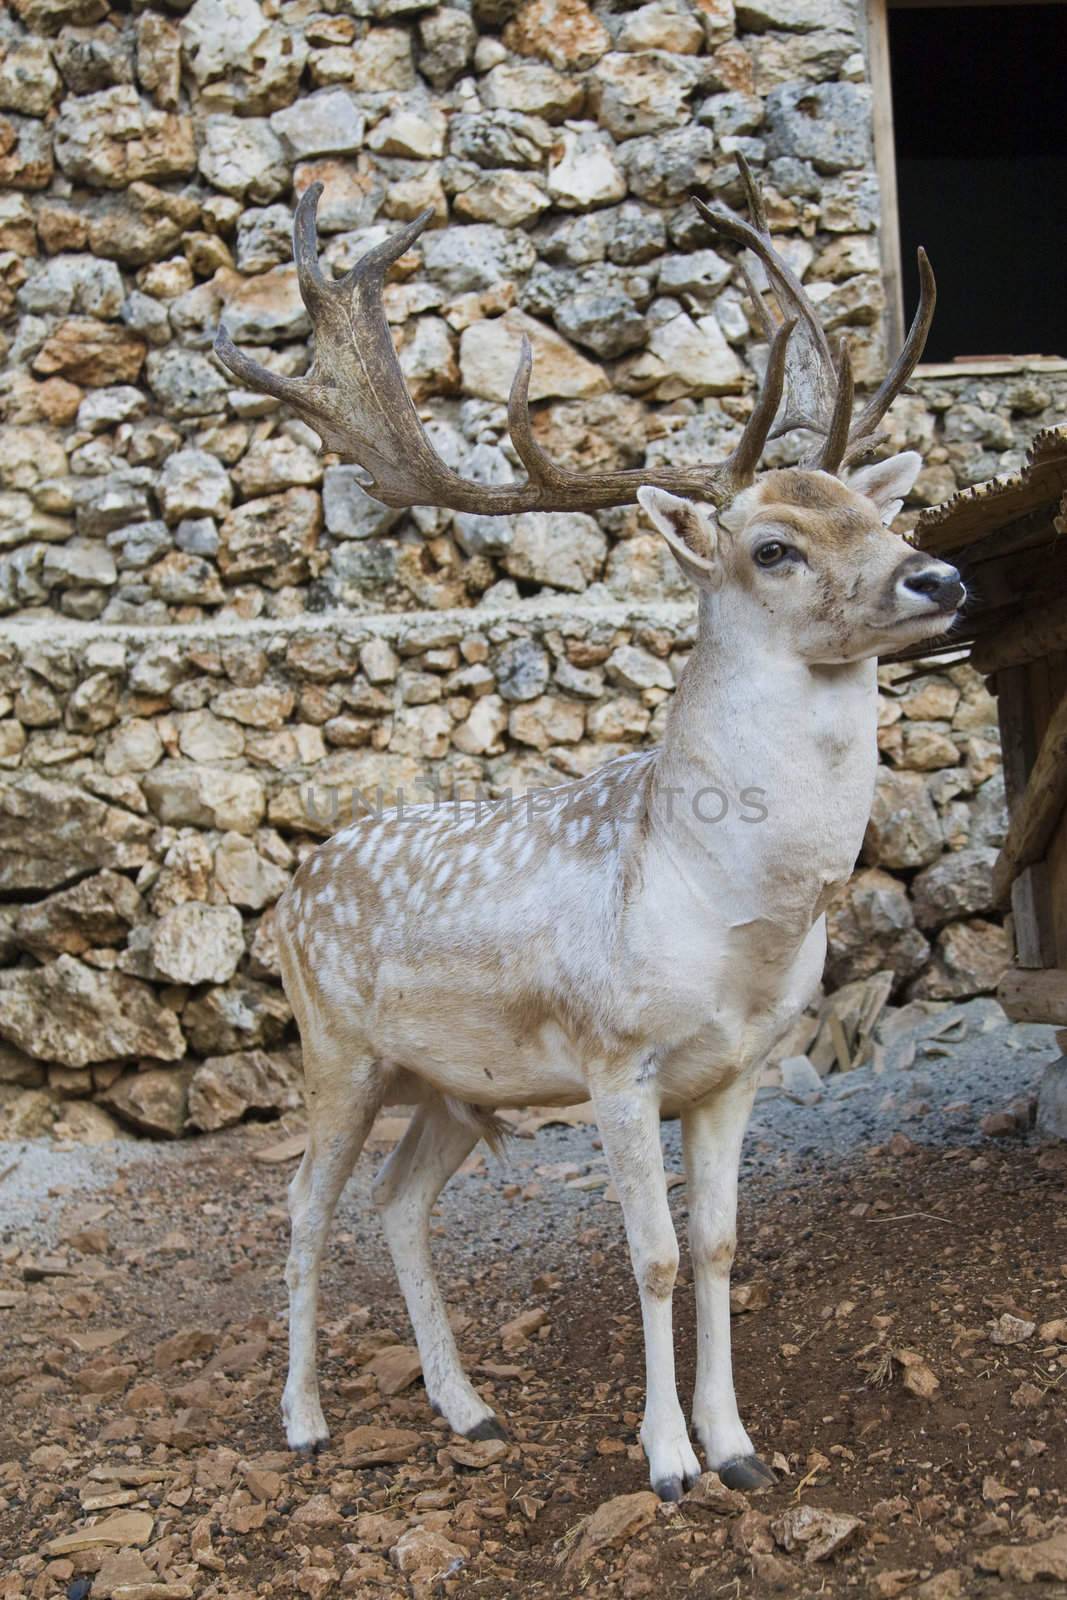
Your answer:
592,1067 -> 701,1501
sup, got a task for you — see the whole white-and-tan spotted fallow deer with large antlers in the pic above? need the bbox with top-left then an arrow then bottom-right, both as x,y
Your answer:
216,160 -> 965,1501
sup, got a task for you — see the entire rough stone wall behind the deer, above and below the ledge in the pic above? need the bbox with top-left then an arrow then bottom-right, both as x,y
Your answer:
0,0 -> 1036,1133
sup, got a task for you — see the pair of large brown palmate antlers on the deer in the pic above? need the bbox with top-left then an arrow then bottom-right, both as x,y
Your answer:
214,152 -> 933,515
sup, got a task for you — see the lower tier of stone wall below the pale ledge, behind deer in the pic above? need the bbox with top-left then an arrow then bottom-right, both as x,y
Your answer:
0,606 -> 1005,1134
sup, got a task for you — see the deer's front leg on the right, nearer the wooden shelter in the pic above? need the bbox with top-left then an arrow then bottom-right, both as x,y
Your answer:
681,1077 -> 774,1490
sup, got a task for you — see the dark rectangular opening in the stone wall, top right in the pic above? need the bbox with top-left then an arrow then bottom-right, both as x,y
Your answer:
888,0 -> 1067,362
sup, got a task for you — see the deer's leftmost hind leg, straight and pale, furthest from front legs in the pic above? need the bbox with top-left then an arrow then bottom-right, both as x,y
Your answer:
282,1042 -> 382,1451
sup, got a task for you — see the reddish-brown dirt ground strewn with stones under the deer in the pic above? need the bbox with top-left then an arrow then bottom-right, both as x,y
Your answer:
0,1088 -> 1067,1600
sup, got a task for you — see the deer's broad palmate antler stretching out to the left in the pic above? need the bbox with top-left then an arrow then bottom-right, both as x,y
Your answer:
214,184 -> 795,515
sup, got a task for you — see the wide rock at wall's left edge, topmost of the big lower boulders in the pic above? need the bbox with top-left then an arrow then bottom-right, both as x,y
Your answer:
0,774 -> 152,893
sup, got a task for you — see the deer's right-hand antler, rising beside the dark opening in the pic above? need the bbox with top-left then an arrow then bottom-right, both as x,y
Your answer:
696,152 -> 937,472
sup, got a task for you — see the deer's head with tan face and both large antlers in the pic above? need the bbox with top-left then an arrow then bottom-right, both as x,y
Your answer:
214,155 -> 961,659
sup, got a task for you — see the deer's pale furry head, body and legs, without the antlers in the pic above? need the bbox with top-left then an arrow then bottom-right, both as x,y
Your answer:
277,462 -> 959,1490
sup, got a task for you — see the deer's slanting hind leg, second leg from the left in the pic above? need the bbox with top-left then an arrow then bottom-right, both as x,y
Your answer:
374,1096 -> 506,1438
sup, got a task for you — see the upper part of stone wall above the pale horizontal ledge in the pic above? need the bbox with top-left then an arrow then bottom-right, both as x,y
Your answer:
0,0 -> 1067,626
